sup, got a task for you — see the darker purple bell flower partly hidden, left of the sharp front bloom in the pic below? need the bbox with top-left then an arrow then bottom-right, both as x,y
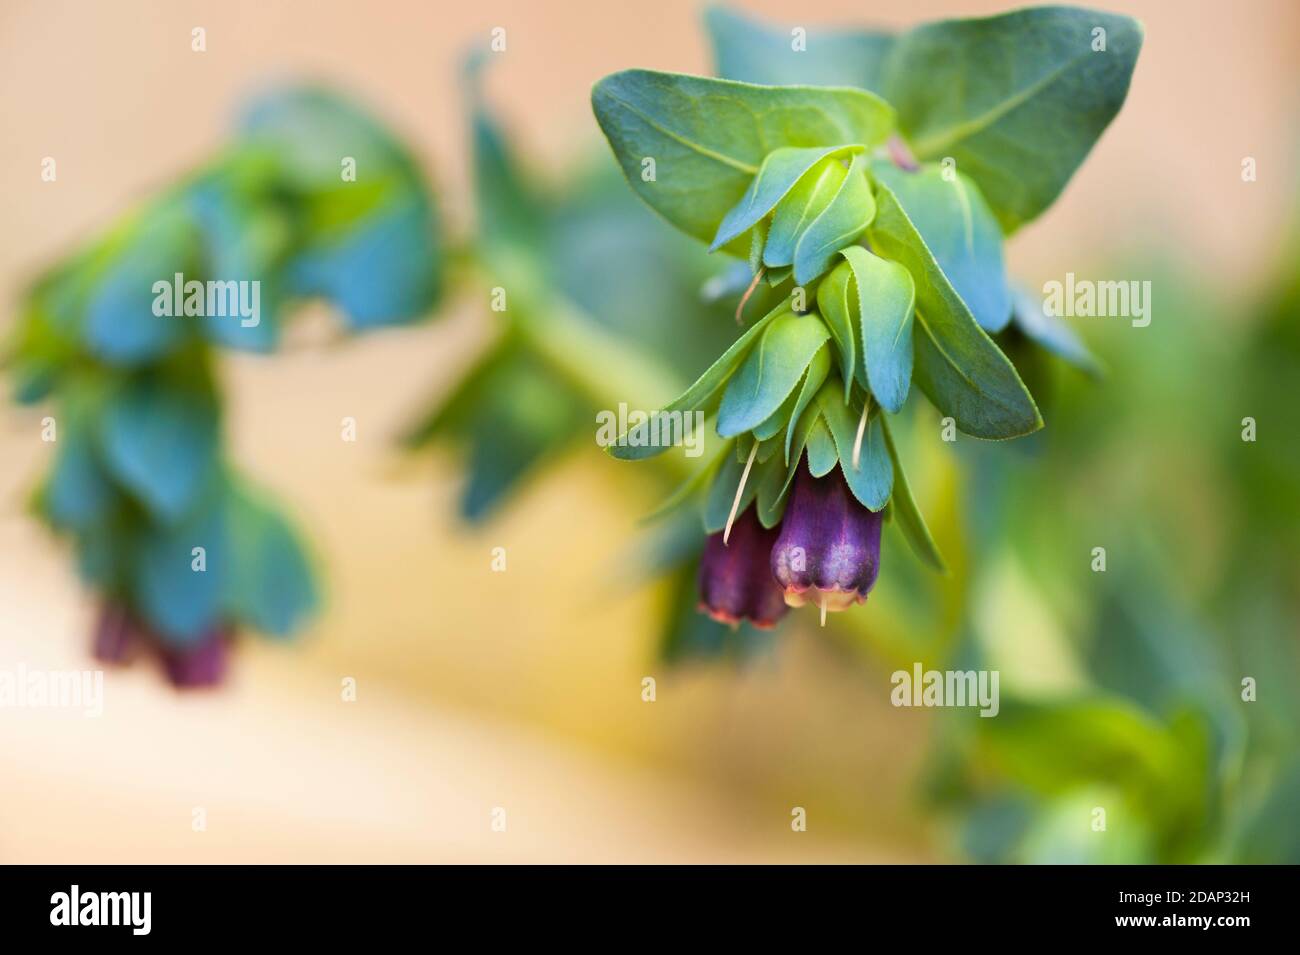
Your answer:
699,507 -> 785,630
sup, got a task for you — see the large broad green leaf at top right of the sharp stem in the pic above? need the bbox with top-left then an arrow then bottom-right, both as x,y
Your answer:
884,6 -> 1143,233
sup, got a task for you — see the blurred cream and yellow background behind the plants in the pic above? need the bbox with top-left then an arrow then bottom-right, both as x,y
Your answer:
0,0 -> 1300,861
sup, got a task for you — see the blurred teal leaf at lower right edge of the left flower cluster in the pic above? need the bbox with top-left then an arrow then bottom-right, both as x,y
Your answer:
225,487 -> 320,637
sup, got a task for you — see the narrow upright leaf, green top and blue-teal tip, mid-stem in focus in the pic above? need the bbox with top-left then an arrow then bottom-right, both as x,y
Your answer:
844,246 -> 917,413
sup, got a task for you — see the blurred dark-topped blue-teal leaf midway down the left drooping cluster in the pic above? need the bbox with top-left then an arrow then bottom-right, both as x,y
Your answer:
100,377 -> 217,522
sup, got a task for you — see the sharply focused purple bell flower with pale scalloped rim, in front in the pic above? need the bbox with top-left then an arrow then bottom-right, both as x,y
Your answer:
771,463 -> 883,611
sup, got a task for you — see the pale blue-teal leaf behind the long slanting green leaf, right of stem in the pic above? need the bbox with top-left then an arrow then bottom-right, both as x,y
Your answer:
871,160 -> 1011,333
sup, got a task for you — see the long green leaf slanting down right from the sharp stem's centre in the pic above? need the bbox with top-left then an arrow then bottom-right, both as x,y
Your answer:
867,183 -> 1043,438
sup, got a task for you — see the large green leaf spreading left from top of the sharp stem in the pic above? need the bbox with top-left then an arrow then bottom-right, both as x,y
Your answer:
592,70 -> 893,256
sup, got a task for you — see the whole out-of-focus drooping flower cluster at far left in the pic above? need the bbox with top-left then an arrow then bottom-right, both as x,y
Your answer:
5,90 -> 441,686
